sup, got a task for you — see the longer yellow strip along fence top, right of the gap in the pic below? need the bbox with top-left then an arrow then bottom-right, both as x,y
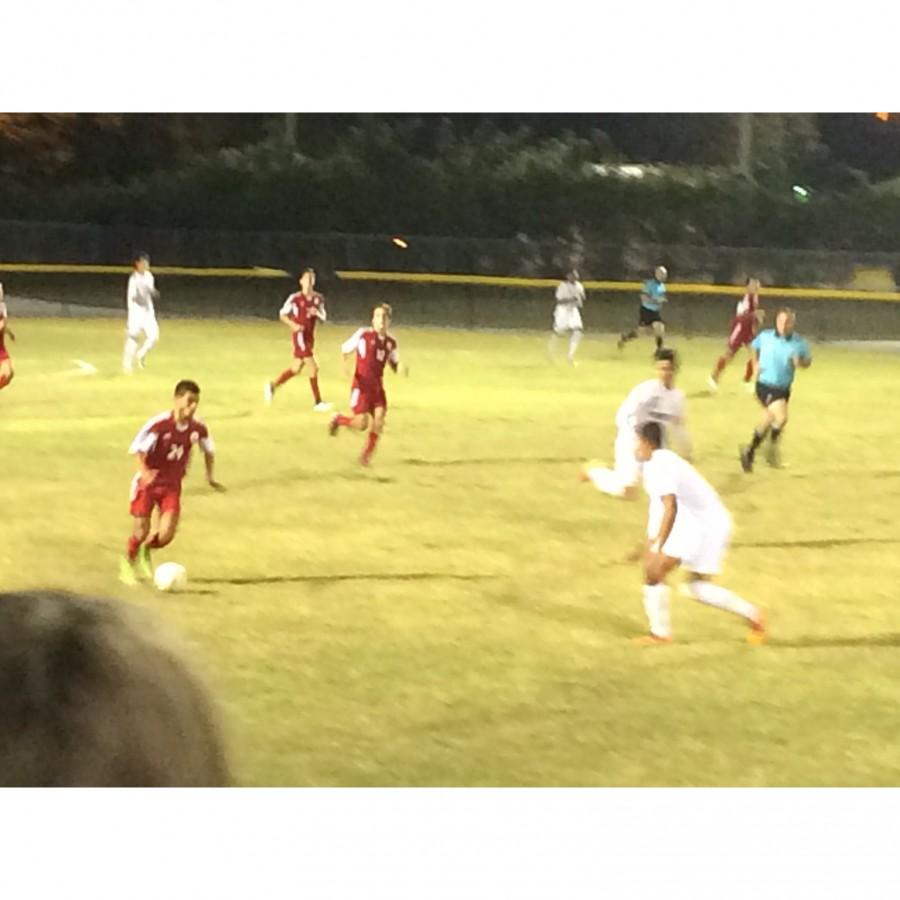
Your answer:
335,269 -> 900,303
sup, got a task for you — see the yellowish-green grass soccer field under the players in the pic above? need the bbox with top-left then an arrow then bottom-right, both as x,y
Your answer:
0,320 -> 900,785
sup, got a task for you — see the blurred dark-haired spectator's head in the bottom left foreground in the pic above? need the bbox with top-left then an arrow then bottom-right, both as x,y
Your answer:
0,591 -> 230,787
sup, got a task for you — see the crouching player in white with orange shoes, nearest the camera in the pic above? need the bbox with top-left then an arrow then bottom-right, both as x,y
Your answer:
631,422 -> 766,644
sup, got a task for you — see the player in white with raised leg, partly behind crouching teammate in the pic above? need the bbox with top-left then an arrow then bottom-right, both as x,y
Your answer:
582,349 -> 691,500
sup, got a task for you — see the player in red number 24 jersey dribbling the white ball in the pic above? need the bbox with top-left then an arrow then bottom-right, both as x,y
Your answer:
119,381 -> 225,585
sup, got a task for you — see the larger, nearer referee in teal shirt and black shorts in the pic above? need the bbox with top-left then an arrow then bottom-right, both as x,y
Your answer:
740,307 -> 812,472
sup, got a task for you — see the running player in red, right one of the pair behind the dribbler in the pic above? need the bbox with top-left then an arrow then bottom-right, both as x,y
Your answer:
328,303 -> 409,466
